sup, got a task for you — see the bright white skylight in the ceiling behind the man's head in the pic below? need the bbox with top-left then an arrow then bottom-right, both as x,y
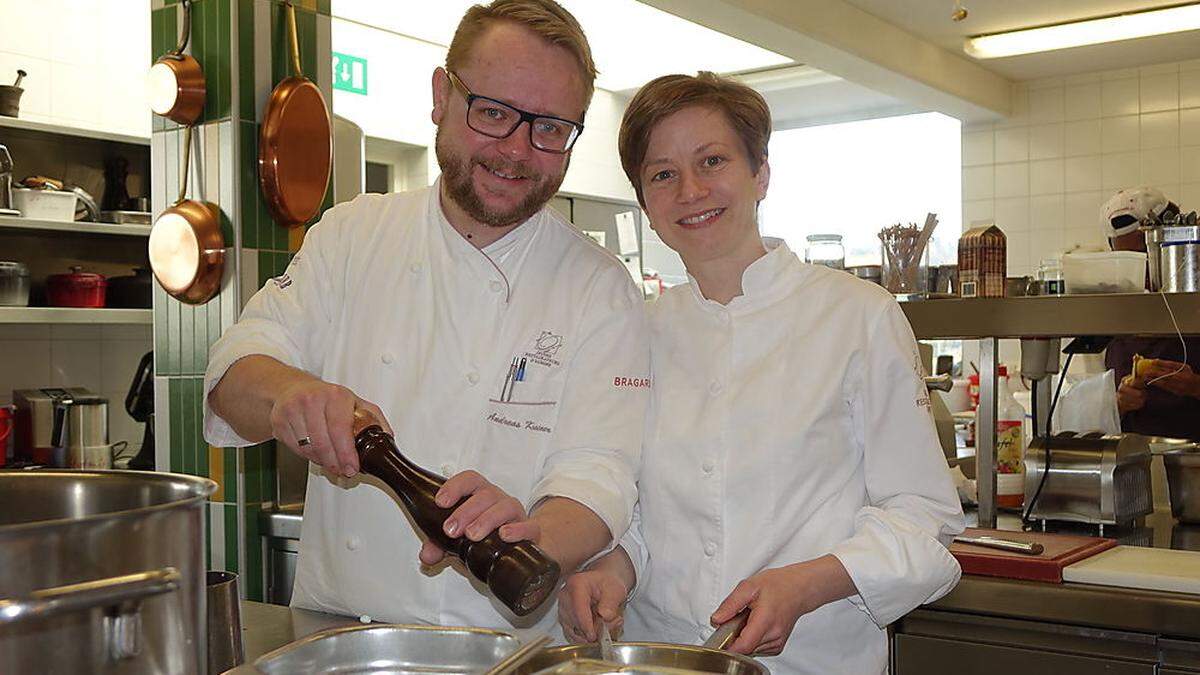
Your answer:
332,0 -> 792,91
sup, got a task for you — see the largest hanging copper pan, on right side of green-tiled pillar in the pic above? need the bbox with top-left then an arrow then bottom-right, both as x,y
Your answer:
258,2 -> 334,227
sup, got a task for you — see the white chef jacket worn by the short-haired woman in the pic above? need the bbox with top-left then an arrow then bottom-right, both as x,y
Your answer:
623,240 -> 964,675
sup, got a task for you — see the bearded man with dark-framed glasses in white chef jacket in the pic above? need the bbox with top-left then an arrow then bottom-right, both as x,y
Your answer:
204,0 -> 649,629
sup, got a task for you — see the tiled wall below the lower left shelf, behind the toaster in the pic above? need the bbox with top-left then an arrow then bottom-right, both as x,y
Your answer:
0,324 -> 151,449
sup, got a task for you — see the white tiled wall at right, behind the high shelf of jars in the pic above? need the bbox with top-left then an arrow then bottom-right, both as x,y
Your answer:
962,60 -> 1200,275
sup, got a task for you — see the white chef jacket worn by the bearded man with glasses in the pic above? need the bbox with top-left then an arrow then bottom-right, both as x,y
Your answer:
204,180 -> 649,629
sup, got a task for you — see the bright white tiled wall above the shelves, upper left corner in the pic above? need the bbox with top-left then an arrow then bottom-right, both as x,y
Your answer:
0,0 -> 151,137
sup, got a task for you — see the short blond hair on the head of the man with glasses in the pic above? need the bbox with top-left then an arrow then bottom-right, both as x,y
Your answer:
446,0 -> 596,110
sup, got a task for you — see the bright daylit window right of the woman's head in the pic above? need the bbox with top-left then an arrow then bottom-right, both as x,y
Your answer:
758,113 -> 962,265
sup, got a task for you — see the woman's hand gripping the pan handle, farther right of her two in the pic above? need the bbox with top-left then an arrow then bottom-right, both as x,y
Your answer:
712,555 -> 858,656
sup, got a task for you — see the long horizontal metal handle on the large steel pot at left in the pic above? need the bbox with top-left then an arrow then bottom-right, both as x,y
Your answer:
0,567 -> 180,626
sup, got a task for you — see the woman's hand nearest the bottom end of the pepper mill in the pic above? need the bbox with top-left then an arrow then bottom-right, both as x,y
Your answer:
558,546 -> 636,643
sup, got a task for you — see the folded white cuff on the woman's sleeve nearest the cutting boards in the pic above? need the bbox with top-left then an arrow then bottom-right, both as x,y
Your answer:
830,515 -> 962,628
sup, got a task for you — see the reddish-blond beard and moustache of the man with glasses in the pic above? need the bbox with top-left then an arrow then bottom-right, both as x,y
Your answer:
434,127 -> 566,227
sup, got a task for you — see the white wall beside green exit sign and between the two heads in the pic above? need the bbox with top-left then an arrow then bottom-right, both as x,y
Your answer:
324,17 -> 634,199
